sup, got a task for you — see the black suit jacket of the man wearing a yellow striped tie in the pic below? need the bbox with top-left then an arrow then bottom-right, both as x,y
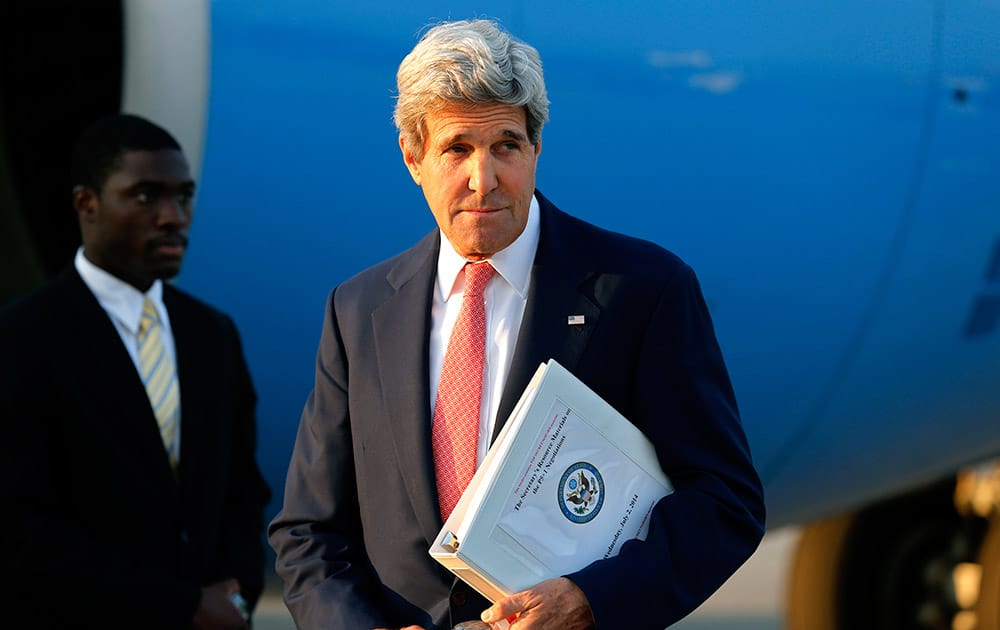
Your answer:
0,267 -> 269,628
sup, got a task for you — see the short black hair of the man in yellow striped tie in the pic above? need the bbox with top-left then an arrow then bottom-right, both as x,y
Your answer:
70,113 -> 181,191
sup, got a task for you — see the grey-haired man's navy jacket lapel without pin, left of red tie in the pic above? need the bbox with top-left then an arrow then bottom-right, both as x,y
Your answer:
372,230 -> 442,544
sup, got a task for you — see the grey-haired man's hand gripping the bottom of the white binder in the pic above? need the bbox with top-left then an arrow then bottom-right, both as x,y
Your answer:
483,578 -> 594,630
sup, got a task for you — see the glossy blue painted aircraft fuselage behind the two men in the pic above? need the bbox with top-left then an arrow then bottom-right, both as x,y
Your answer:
174,0 -> 1000,526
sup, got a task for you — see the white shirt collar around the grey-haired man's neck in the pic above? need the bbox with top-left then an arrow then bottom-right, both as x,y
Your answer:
437,196 -> 541,300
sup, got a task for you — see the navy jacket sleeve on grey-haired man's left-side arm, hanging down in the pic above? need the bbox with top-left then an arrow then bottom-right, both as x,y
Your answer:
269,292 -> 388,628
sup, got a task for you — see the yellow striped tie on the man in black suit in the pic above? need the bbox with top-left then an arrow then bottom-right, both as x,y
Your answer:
138,298 -> 180,471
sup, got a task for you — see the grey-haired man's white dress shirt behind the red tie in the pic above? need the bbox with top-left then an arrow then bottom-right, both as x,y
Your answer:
430,197 -> 541,466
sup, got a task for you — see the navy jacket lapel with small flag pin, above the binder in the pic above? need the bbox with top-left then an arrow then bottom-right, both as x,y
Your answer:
493,194 -> 601,439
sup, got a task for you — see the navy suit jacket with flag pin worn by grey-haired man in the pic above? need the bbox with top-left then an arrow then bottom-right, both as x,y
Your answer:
270,195 -> 764,629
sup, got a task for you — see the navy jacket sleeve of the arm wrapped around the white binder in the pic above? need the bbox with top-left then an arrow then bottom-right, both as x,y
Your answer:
568,264 -> 764,629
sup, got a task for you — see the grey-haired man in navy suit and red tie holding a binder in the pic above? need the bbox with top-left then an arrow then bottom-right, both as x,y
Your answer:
270,20 -> 764,630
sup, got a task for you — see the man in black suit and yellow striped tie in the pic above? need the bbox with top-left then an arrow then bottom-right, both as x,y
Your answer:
0,115 -> 269,629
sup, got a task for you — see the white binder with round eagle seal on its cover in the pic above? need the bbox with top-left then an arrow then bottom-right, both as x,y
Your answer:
429,360 -> 673,602
